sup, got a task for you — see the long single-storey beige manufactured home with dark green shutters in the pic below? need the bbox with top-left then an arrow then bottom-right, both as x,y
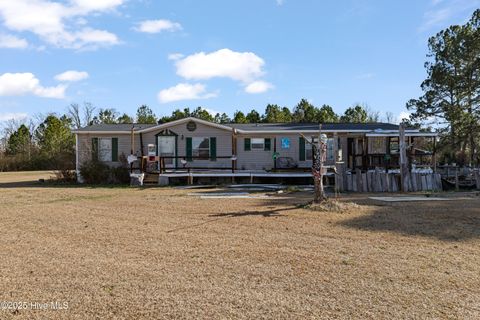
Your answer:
74,117 -> 436,185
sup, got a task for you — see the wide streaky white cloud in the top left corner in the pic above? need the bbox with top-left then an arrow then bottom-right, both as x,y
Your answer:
0,0 -> 124,49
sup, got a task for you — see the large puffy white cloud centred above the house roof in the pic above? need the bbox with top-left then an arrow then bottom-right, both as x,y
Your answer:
175,49 -> 265,84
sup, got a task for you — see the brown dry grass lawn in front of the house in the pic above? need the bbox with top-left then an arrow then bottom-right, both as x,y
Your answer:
0,173 -> 480,319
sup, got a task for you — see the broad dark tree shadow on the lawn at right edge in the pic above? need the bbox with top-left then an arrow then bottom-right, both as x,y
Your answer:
338,199 -> 480,241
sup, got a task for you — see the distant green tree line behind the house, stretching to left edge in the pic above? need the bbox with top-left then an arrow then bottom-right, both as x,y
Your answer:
0,99 -> 394,175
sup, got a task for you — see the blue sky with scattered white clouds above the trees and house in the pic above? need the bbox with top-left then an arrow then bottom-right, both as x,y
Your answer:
0,0 -> 480,121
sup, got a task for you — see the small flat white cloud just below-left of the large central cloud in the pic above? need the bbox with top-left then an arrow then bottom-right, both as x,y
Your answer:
158,83 -> 217,103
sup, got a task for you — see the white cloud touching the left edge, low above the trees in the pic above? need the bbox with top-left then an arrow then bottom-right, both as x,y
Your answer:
0,72 -> 67,99
